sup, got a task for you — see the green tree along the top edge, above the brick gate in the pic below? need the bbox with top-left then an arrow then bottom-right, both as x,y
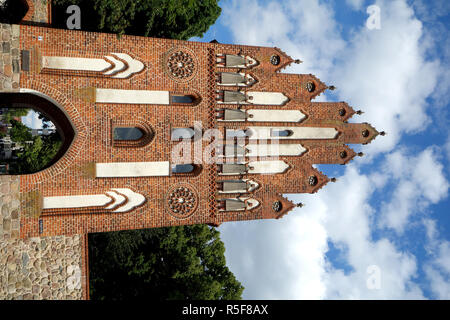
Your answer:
52,0 -> 221,40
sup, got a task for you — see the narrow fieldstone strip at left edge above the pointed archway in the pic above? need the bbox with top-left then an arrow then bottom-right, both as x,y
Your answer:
0,24 -> 20,91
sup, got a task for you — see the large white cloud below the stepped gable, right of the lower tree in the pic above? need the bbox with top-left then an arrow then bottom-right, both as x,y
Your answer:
220,165 -> 423,299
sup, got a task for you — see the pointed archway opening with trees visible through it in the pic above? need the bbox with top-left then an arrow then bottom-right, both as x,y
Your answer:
0,93 -> 76,175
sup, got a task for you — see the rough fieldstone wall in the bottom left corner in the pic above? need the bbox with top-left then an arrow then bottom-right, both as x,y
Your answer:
0,235 -> 85,300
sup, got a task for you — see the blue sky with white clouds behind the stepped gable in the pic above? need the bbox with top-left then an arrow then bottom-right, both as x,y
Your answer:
193,0 -> 450,299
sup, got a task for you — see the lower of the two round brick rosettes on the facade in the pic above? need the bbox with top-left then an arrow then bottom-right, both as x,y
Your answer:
166,183 -> 199,219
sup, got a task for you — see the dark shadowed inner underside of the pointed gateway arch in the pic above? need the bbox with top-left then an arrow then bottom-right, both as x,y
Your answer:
0,90 -> 77,174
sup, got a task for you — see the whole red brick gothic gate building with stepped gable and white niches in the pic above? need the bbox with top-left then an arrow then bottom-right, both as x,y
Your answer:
0,1 -> 379,296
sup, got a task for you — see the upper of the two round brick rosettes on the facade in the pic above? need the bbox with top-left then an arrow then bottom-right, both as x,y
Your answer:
165,48 -> 198,81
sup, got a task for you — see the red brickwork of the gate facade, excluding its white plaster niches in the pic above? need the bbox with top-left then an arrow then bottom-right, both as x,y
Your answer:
7,25 -> 378,238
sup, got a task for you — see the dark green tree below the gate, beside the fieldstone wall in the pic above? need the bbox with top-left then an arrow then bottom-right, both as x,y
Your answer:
89,225 -> 244,300
